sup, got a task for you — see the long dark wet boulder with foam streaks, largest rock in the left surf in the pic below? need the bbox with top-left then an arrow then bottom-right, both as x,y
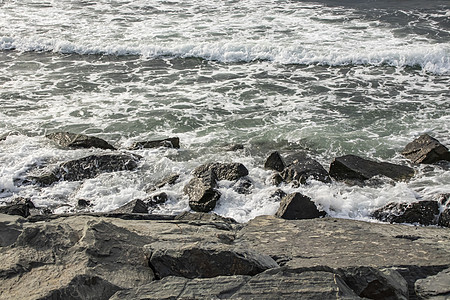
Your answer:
28,154 -> 140,186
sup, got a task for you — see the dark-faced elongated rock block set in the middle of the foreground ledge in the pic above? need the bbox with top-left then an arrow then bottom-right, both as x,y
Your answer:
146,243 -> 278,278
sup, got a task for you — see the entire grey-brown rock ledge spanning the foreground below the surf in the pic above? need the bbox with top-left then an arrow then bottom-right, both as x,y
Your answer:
0,213 -> 450,299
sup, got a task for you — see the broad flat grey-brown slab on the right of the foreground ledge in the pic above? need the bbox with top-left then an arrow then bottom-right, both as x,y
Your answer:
234,216 -> 450,268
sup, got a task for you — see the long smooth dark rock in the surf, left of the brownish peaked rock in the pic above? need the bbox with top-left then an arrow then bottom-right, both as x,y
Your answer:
330,155 -> 414,181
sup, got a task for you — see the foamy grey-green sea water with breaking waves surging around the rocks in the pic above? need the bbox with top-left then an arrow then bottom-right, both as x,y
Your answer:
0,0 -> 450,222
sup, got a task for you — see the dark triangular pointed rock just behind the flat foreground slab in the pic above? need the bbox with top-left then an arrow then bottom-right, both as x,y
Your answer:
275,193 -> 325,220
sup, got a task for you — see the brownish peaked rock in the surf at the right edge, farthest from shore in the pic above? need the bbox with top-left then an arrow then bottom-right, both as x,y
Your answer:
402,134 -> 450,164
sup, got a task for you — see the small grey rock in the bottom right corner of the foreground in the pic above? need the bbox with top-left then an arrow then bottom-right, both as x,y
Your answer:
415,269 -> 450,300
